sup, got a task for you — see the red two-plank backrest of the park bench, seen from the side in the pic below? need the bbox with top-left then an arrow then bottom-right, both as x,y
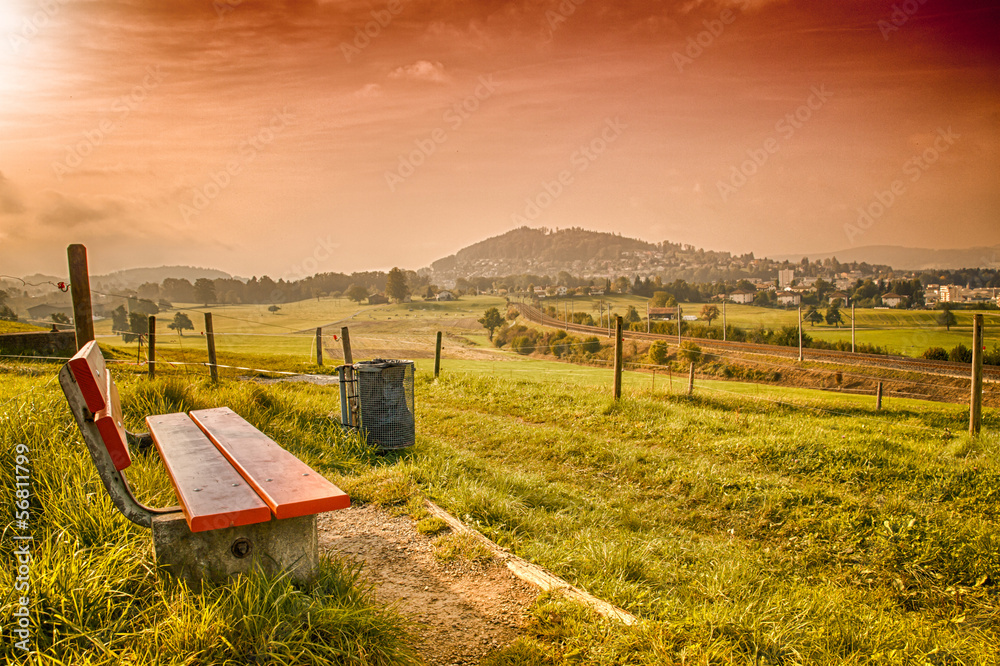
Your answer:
68,340 -> 132,471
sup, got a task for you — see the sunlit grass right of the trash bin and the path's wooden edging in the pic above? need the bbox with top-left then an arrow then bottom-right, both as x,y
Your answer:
406,376 -> 1000,665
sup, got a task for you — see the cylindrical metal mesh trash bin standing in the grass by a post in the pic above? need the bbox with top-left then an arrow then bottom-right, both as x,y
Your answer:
354,359 -> 416,450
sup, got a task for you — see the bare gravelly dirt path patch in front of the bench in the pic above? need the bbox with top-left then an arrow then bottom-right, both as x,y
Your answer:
319,505 -> 538,666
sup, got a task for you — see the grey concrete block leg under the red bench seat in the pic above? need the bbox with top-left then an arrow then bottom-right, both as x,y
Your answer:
153,512 -> 319,585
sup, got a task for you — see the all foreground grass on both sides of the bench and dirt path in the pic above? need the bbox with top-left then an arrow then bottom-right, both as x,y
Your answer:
0,340 -> 1000,666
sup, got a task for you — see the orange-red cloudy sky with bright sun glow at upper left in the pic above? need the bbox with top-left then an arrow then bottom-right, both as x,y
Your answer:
0,0 -> 1000,279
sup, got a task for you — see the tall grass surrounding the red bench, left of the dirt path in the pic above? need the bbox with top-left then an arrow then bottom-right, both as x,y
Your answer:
0,364 -> 416,666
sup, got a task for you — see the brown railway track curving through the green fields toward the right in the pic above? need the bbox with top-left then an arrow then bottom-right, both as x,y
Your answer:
511,303 -> 1000,382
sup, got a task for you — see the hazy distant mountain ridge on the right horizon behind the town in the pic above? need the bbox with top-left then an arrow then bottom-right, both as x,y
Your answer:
772,245 -> 1000,271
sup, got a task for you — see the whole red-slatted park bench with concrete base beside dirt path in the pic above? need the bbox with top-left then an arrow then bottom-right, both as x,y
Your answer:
59,341 -> 350,582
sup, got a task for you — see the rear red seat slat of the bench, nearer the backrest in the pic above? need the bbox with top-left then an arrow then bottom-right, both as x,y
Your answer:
146,413 -> 271,532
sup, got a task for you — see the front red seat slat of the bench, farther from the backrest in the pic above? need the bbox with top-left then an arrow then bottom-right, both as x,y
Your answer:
191,407 -> 351,519
